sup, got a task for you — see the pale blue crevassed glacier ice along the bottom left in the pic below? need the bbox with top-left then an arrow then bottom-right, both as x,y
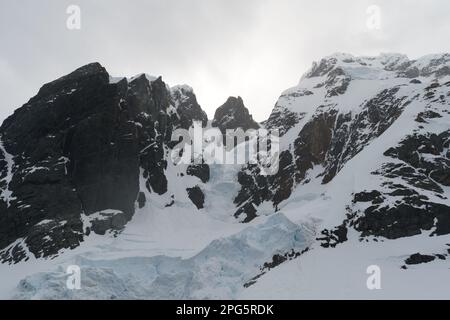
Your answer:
11,214 -> 311,299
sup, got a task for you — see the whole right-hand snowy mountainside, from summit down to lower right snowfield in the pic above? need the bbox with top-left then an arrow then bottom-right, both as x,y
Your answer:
232,54 -> 450,299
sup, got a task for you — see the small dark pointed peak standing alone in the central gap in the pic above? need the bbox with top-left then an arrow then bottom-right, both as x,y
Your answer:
212,97 -> 259,133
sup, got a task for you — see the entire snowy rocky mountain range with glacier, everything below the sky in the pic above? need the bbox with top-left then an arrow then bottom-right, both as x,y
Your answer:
0,54 -> 450,299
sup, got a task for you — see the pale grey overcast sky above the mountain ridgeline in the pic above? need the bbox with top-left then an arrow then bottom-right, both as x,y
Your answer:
0,0 -> 450,121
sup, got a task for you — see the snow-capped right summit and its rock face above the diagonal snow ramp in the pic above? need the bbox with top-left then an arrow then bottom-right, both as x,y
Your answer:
236,54 -> 450,219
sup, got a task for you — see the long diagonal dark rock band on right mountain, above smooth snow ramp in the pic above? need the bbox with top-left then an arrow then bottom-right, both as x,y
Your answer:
235,87 -> 409,222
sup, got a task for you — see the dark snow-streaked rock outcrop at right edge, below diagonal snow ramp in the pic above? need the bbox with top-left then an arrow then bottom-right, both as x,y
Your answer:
353,130 -> 450,239
